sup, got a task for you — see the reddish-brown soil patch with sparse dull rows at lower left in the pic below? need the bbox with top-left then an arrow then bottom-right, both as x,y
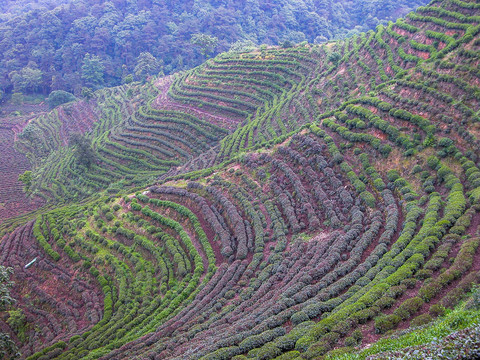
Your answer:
0,221 -> 103,356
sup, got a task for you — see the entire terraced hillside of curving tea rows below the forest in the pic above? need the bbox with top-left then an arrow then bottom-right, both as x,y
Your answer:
0,0 -> 480,360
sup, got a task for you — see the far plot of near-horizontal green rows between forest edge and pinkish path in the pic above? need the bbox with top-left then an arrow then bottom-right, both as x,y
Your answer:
169,47 -> 316,120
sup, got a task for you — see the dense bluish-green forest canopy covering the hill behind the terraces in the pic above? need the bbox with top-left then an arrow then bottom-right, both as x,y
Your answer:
0,0 -> 428,95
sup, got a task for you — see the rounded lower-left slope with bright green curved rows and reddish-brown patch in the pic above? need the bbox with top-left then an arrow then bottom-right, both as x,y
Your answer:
1,193 -> 218,358
